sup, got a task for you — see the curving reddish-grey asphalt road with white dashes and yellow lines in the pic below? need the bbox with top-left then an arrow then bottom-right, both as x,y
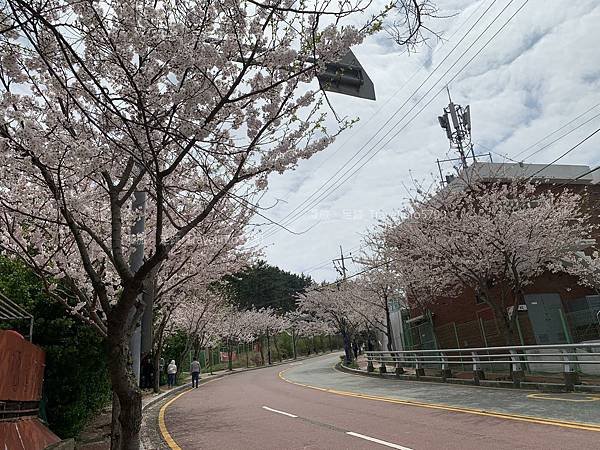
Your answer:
163,355 -> 600,450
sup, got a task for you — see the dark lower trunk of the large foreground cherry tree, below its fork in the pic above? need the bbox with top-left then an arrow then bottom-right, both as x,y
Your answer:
107,321 -> 142,450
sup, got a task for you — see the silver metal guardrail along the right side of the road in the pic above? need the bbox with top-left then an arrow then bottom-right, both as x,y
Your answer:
365,343 -> 600,385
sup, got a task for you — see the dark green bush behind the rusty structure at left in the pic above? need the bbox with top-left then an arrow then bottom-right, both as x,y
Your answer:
0,256 -> 111,438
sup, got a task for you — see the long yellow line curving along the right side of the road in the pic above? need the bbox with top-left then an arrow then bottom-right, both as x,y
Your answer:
279,368 -> 600,432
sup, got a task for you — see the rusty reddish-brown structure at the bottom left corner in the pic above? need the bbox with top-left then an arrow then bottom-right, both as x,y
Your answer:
0,330 -> 60,450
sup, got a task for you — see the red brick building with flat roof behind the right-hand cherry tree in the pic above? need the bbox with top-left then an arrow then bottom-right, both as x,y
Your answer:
402,163 -> 600,349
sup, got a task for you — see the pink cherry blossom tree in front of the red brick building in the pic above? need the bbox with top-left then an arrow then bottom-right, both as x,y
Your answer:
386,180 -> 593,345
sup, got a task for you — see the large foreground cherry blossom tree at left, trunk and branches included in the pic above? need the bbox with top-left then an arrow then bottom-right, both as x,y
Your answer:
0,0 -> 426,449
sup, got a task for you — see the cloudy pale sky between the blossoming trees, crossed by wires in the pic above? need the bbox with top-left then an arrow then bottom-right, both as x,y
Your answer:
255,0 -> 600,281
